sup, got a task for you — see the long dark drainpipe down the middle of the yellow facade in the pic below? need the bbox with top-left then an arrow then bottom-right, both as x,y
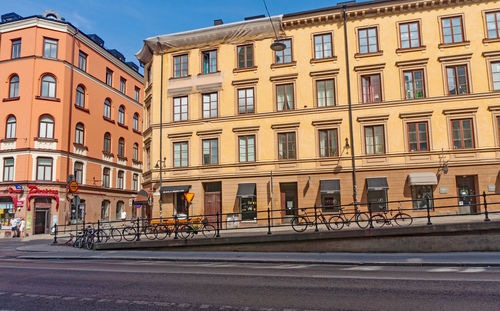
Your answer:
342,5 -> 358,210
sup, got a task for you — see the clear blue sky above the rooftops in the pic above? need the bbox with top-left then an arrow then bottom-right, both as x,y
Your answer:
0,0 -> 372,70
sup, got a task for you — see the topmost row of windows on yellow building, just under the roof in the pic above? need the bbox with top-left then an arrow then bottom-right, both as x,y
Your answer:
154,11 -> 500,82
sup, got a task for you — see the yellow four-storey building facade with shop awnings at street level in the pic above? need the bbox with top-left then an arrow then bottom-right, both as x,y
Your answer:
137,0 -> 500,222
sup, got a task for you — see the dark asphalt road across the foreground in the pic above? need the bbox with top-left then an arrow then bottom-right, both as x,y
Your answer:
0,258 -> 500,311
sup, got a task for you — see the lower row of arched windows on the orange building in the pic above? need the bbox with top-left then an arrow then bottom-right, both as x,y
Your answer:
5,115 -> 139,161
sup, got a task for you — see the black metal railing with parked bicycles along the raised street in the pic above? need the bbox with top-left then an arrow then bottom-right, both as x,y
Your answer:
53,192 -> 500,249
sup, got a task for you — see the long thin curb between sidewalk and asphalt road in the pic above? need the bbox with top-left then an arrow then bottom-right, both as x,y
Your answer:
16,255 -> 500,267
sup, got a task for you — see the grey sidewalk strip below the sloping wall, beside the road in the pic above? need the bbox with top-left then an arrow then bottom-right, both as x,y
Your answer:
13,244 -> 500,267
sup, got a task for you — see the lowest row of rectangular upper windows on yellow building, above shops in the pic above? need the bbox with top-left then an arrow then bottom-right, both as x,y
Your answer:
159,117 -> 488,169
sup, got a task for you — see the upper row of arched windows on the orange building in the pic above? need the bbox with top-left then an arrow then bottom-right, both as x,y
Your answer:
5,74 -> 139,132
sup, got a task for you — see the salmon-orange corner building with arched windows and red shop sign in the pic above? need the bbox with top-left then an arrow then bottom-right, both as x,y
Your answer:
0,11 -> 143,236
